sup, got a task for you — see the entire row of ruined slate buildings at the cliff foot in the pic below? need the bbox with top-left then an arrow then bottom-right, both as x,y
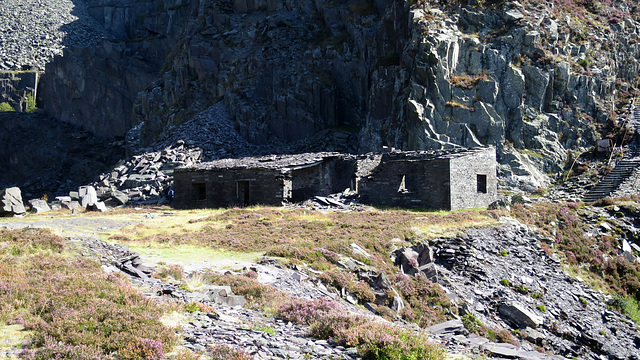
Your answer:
174,147 -> 497,210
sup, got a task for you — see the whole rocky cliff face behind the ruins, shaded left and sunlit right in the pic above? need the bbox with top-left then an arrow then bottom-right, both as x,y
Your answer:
33,0 -> 640,189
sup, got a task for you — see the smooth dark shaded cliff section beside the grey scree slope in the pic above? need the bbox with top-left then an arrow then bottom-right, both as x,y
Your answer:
40,0 -> 195,137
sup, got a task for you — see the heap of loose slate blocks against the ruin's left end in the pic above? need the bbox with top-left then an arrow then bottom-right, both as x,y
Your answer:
93,140 -> 203,206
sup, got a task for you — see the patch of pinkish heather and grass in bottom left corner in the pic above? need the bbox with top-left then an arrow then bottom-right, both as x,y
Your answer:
0,229 -> 176,359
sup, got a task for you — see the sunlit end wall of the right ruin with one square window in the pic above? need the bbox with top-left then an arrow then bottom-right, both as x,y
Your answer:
449,148 -> 498,210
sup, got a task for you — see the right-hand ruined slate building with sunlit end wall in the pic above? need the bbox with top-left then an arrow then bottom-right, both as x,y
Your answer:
357,147 -> 498,210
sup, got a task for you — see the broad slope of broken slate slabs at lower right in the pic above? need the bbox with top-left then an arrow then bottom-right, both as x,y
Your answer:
396,219 -> 640,359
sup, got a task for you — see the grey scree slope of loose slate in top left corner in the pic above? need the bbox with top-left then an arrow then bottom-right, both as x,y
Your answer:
0,0 -> 109,70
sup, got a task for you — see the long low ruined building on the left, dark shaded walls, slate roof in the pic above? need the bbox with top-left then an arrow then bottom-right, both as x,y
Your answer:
174,153 -> 356,208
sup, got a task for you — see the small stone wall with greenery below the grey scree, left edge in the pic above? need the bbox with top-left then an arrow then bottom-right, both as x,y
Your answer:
0,71 -> 40,111
